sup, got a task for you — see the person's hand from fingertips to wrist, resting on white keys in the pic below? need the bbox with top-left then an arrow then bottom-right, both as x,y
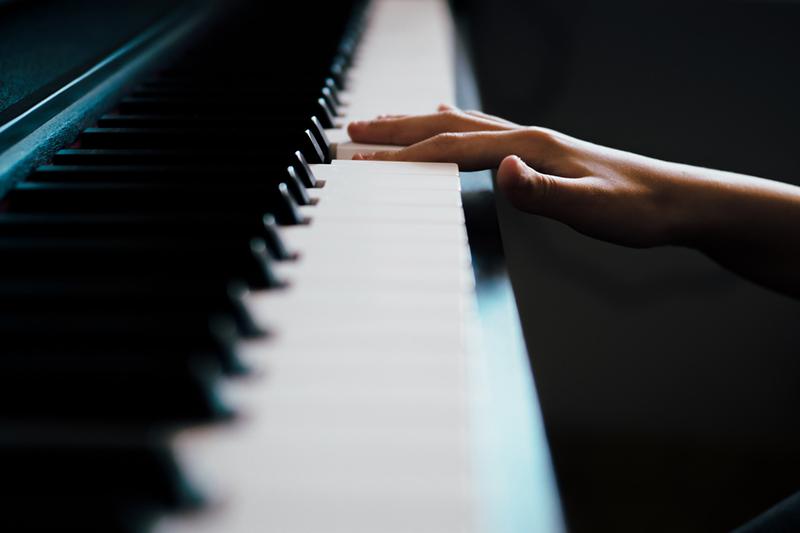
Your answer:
348,106 -> 692,246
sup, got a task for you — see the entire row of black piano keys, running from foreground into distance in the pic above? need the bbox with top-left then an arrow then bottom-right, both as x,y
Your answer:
0,2 -> 368,531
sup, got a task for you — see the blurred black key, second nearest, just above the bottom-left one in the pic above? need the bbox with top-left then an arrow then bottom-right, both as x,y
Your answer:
0,360 -> 227,426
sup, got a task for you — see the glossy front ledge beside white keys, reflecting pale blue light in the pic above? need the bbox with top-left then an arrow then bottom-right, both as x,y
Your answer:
454,12 -> 566,532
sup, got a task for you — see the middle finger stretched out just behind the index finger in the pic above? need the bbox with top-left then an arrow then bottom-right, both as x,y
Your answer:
347,109 -> 510,145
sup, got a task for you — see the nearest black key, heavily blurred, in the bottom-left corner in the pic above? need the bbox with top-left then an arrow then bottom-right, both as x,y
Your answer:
0,436 -> 203,531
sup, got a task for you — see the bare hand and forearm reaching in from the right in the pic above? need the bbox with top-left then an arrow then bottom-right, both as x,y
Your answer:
348,105 -> 800,297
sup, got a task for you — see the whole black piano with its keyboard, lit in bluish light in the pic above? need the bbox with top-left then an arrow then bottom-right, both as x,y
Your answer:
0,0 -> 565,533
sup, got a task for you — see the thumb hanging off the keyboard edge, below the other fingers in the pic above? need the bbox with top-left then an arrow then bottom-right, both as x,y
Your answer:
497,155 -> 584,219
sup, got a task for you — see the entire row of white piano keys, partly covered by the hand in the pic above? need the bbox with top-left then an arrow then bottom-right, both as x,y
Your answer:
157,0 -> 474,533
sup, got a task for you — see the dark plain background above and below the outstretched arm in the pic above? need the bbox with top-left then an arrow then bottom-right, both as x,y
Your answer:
465,0 -> 800,531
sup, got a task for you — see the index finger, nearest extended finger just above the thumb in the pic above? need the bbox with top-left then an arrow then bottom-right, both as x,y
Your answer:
354,130 -> 546,170
